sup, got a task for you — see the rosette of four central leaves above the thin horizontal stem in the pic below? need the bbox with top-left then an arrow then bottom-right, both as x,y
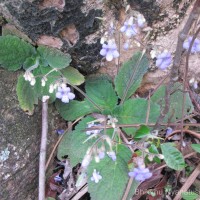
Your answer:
56,52 -> 160,134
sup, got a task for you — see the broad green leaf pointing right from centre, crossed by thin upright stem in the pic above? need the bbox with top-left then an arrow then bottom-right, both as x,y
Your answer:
113,98 -> 160,135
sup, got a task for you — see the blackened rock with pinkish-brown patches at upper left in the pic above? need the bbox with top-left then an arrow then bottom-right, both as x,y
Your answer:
0,0 -> 102,73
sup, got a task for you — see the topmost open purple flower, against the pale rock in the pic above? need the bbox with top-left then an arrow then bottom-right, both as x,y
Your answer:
120,17 -> 138,38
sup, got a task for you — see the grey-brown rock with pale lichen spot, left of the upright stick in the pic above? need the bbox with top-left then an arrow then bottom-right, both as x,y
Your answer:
0,68 -> 57,200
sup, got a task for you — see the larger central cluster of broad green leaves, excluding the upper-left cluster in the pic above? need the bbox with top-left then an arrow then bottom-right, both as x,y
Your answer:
56,52 -> 193,200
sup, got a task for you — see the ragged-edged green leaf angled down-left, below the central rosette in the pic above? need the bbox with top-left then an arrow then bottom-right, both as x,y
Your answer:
57,117 -> 95,166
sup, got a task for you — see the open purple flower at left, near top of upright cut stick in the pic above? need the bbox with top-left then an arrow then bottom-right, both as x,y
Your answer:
56,84 -> 75,103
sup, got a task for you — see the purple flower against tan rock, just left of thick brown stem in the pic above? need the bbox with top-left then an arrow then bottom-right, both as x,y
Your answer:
156,51 -> 172,70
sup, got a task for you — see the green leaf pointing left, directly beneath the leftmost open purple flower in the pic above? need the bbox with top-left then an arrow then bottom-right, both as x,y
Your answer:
56,100 -> 98,121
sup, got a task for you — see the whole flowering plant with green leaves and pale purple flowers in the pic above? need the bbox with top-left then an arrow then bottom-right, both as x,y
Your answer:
0,9 -> 199,200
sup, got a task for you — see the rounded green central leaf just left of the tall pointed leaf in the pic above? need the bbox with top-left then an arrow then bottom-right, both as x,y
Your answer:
85,76 -> 118,114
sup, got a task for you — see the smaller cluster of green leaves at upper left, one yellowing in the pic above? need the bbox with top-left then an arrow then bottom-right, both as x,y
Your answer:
0,35 -> 84,114
